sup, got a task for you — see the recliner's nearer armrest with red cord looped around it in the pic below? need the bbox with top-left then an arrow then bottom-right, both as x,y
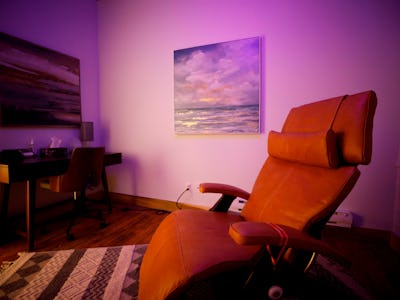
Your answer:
229,222 -> 350,266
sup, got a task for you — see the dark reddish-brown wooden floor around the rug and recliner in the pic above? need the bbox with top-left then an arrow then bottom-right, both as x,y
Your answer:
0,203 -> 400,299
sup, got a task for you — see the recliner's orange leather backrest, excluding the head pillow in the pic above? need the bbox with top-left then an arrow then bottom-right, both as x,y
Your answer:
242,91 -> 376,231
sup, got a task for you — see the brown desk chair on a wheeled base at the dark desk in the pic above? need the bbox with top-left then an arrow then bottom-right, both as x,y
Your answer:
40,147 -> 106,240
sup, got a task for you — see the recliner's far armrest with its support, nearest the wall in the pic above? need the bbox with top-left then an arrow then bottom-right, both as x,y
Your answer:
199,182 -> 250,212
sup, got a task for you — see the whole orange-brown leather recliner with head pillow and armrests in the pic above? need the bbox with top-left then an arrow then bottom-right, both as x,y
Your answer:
139,91 -> 377,300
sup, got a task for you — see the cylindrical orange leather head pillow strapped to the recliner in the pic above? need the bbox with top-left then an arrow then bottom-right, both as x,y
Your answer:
268,130 -> 339,168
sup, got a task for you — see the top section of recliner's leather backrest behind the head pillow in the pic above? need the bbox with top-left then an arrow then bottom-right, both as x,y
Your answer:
282,91 -> 377,164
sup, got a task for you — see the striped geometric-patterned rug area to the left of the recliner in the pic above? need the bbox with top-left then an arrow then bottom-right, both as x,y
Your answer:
0,245 -> 147,299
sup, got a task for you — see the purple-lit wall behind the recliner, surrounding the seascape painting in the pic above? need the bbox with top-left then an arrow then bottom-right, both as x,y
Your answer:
98,0 -> 400,229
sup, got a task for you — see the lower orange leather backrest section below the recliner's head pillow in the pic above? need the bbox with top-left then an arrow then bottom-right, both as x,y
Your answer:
242,157 -> 359,231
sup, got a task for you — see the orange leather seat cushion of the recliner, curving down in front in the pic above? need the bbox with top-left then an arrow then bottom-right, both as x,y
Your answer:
139,210 -> 259,299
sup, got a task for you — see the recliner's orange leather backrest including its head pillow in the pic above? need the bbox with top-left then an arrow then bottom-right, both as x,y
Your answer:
242,91 -> 377,235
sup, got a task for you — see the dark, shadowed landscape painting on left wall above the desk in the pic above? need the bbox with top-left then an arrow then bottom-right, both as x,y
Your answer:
0,32 -> 81,127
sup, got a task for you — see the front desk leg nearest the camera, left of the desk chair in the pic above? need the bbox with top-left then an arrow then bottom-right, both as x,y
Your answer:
26,179 -> 36,251
